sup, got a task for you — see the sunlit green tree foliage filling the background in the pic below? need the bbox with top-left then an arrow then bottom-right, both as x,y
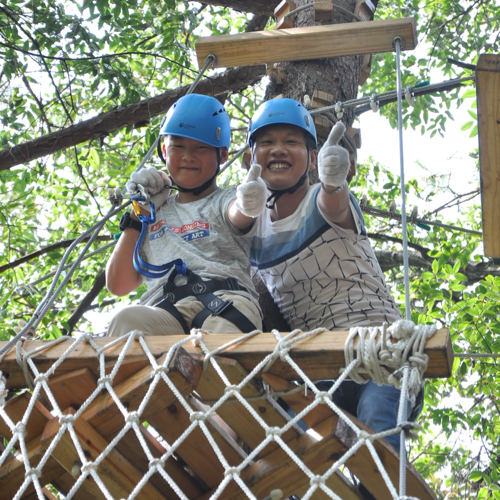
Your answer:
0,0 -> 500,499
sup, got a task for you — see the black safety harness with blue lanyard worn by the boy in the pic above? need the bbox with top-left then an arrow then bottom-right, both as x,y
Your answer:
132,197 -> 257,335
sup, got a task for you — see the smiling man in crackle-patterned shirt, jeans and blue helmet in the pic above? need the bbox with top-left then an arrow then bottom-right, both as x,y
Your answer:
249,99 -> 418,458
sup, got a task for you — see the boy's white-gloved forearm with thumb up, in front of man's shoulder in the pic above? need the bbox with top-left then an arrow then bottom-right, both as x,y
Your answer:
227,164 -> 267,230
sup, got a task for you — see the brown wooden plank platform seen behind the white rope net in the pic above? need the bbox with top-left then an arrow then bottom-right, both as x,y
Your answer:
0,330 -> 442,500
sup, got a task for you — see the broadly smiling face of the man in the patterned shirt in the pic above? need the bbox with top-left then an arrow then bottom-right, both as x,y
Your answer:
252,125 -> 316,189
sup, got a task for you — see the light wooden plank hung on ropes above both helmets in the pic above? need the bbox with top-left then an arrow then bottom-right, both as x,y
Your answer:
195,17 -> 417,68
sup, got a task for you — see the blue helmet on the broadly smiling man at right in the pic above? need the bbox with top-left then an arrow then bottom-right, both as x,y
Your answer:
248,98 -> 318,149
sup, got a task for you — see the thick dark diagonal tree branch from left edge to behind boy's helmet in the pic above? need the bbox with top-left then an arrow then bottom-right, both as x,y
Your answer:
0,64 -> 266,171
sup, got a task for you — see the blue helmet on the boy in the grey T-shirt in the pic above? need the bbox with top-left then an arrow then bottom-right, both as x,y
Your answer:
160,94 -> 231,149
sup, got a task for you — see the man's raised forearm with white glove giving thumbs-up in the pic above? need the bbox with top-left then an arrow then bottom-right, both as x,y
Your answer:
318,122 -> 357,231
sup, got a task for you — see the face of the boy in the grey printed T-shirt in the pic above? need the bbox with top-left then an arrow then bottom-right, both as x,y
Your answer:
162,135 -> 228,189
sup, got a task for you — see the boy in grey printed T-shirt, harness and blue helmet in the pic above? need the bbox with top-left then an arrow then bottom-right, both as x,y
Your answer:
106,94 -> 265,336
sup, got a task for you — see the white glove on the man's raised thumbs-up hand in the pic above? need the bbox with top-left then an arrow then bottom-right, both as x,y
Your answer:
318,122 -> 351,186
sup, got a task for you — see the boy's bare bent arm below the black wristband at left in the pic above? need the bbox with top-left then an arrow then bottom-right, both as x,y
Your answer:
106,211 -> 142,297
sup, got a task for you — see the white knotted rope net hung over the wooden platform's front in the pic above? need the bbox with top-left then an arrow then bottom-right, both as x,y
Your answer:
0,321 -> 436,500
